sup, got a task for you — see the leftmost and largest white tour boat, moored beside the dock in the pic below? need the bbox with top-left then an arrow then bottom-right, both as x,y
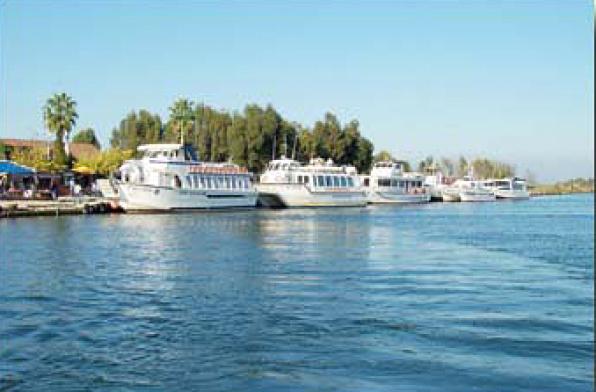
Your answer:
118,144 -> 257,211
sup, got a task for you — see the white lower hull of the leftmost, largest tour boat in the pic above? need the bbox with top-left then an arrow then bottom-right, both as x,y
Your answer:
118,184 -> 257,212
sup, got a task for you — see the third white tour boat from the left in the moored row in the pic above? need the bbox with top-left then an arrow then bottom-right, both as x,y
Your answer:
360,161 -> 431,204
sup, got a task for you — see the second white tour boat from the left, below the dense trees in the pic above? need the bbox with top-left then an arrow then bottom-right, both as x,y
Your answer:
257,156 -> 366,208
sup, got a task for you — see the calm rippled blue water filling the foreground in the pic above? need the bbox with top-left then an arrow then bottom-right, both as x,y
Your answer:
0,195 -> 594,391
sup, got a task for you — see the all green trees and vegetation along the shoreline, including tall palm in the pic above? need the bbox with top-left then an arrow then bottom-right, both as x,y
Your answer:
0,92 -> 594,195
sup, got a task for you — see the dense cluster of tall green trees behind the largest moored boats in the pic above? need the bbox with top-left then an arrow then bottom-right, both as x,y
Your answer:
110,99 -> 374,172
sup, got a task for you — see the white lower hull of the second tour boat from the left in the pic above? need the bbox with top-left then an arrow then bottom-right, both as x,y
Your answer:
257,184 -> 367,208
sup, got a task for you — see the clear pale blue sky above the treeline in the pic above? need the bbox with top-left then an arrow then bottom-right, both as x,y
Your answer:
0,0 -> 594,181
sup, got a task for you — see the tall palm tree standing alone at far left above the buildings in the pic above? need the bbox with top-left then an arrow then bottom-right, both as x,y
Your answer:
43,93 -> 79,165
